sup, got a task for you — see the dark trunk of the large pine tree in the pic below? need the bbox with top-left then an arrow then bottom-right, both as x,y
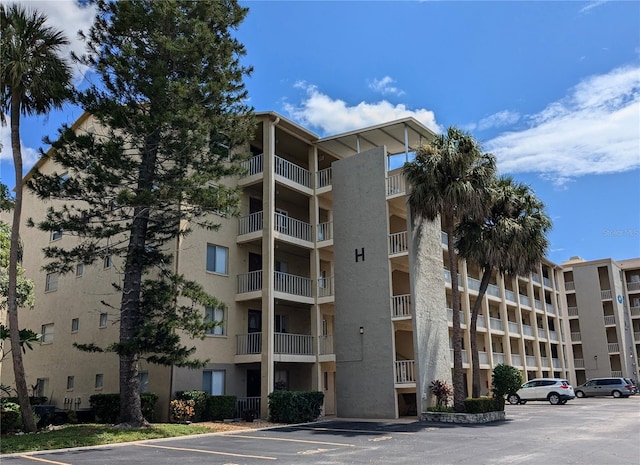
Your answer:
120,132 -> 158,427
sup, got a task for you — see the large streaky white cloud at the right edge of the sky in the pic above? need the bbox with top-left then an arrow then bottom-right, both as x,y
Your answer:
484,66 -> 640,185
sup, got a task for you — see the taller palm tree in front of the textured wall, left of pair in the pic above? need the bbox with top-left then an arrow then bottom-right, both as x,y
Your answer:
404,127 -> 496,412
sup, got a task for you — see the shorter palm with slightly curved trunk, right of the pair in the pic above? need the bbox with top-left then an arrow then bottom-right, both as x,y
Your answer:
456,177 -> 551,397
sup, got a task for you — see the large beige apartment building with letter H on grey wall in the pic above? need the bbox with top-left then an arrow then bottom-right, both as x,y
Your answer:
2,112 -> 576,419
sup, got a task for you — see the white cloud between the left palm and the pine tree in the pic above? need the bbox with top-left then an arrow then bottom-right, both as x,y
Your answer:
16,0 -> 96,84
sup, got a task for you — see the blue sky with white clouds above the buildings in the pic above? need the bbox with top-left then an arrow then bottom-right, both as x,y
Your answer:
0,0 -> 640,263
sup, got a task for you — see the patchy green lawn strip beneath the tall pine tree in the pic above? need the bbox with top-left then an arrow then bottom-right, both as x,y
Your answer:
0,423 -> 215,454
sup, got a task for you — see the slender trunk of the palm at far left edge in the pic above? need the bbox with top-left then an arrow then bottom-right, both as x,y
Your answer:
7,95 -> 37,433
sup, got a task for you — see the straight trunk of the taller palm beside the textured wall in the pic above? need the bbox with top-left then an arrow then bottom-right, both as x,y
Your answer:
444,212 -> 465,412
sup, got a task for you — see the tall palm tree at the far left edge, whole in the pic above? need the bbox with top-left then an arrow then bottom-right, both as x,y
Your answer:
0,4 -> 71,432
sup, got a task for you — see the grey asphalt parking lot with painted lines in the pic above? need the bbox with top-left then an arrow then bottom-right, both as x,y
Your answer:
1,395 -> 640,465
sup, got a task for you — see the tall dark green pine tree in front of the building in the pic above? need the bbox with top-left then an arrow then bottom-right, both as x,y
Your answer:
30,0 -> 254,426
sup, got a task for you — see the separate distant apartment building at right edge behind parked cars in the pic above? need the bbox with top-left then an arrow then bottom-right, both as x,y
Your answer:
562,257 -> 640,384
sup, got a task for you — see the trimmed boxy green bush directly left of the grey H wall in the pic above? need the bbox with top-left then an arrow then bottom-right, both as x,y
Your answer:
269,391 -> 324,423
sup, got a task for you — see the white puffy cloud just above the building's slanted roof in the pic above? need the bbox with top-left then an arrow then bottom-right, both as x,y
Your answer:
284,82 -> 441,135
